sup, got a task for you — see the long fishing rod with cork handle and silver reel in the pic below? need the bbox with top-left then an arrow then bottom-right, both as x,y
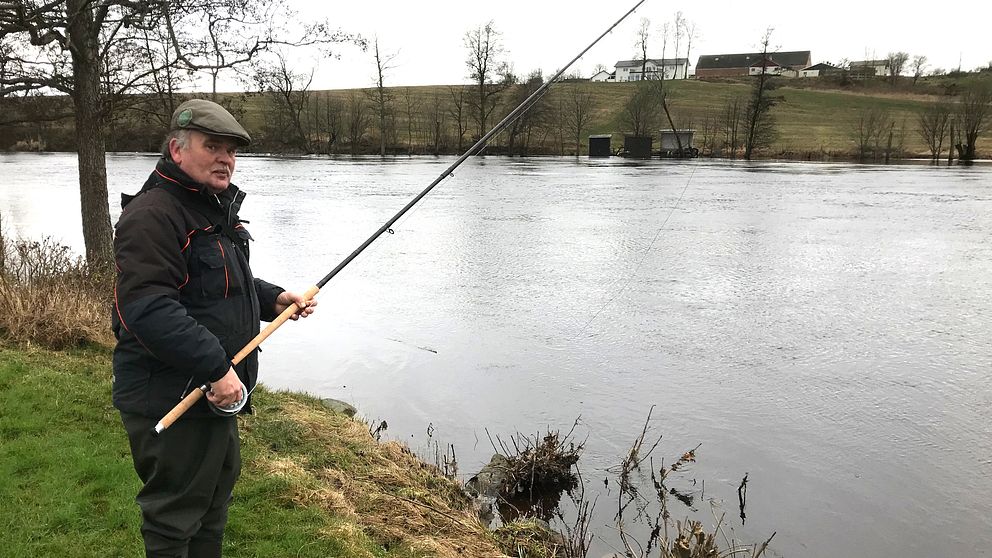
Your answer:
152,0 -> 647,435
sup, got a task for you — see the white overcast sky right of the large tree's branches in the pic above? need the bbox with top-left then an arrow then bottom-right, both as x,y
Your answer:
274,0 -> 992,89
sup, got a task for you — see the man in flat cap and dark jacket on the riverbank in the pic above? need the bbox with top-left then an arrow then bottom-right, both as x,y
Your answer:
113,100 -> 316,558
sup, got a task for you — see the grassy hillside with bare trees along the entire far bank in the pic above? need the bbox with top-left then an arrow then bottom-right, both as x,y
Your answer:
0,75 -> 992,162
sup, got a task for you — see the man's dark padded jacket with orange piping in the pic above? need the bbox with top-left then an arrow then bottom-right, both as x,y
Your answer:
113,159 -> 283,418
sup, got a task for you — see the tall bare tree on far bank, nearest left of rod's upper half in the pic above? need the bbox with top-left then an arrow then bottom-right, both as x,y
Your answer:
464,21 -> 513,142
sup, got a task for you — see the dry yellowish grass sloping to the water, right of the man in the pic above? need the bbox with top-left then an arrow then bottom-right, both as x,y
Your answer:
243,390 -> 504,558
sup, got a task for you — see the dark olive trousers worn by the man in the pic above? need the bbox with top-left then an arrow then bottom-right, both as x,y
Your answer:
121,413 -> 241,558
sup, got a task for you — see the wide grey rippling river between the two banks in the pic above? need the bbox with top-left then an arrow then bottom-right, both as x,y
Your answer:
0,154 -> 992,558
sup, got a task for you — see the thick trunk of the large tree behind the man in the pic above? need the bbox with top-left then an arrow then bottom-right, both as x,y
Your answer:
68,0 -> 113,271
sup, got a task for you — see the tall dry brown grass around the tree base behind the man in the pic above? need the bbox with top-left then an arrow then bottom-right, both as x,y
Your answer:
0,220 -> 113,349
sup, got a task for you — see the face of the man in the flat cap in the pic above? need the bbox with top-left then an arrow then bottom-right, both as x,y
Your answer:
169,130 -> 238,194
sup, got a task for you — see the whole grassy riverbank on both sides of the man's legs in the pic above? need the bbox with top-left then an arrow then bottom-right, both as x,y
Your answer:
0,347 -> 502,558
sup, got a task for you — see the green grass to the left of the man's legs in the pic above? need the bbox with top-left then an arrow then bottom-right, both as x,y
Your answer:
0,350 -> 141,557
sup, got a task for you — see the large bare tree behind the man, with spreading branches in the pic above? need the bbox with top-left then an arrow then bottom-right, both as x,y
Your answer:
0,0 -> 356,269
